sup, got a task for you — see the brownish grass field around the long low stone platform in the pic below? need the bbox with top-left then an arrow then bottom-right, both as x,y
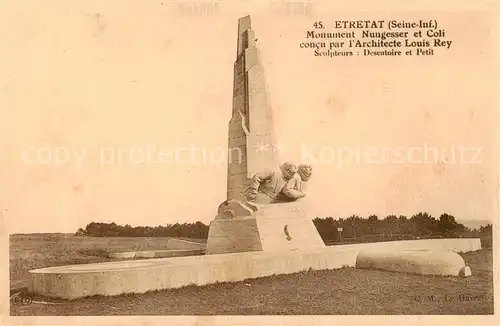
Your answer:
10,235 -> 493,316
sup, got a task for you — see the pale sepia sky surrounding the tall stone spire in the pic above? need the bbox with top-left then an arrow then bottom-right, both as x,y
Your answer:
0,1 -> 499,233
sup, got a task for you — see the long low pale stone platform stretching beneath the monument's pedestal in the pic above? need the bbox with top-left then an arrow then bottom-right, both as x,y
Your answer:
29,239 -> 481,299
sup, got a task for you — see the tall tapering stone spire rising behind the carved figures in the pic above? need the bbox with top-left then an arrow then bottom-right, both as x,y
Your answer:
227,16 -> 278,204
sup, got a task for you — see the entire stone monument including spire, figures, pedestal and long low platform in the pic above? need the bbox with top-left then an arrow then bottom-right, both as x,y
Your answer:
29,16 -> 481,299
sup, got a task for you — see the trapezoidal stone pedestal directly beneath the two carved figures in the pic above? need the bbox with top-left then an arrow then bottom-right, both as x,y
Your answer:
206,202 -> 325,255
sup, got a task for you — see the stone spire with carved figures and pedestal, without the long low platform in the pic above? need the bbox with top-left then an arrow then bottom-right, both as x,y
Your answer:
206,16 -> 324,254
